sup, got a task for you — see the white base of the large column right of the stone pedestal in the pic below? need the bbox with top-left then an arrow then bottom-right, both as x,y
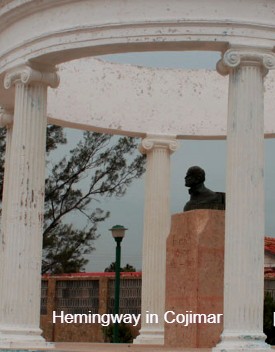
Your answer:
212,332 -> 271,352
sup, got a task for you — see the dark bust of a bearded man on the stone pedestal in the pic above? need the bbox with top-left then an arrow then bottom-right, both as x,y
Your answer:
183,166 -> 225,211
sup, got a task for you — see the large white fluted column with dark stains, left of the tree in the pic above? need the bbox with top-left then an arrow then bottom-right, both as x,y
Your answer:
0,66 -> 58,348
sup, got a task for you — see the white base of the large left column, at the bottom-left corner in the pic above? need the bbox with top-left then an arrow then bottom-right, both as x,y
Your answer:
0,325 -> 54,352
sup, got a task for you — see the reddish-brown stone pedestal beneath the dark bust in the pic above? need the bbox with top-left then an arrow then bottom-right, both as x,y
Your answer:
165,209 -> 225,348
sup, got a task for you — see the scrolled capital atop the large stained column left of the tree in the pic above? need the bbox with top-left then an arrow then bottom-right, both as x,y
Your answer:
4,65 -> 59,89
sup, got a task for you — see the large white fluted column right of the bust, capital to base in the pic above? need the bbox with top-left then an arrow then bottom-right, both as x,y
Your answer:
216,48 -> 275,352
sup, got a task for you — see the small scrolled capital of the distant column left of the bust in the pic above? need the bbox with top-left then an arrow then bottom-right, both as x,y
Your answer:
139,135 -> 179,154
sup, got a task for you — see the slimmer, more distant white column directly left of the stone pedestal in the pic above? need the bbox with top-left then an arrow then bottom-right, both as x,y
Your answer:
134,136 -> 178,344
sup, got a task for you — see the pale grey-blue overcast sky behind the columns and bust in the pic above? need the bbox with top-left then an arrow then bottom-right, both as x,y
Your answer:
59,52 -> 275,272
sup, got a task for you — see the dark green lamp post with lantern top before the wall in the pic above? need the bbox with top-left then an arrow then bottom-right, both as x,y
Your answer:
110,225 -> 128,343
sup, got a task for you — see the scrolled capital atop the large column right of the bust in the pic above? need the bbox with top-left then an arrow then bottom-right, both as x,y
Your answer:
217,47 -> 275,76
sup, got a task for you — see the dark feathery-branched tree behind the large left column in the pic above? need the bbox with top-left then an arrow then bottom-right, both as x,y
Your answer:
0,126 -> 145,273
